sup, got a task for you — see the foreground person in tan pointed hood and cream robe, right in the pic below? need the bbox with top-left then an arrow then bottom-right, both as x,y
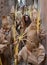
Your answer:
18,30 -> 45,65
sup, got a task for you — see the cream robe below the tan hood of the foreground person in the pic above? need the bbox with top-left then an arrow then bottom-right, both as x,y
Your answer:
18,44 -> 45,65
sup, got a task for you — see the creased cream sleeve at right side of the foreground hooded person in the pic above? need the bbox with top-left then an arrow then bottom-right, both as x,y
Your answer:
38,45 -> 45,64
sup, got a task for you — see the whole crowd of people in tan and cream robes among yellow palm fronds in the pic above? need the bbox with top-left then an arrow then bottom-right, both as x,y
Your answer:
0,5 -> 45,65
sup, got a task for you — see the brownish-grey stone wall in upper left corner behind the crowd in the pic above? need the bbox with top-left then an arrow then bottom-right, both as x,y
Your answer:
0,0 -> 14,27
